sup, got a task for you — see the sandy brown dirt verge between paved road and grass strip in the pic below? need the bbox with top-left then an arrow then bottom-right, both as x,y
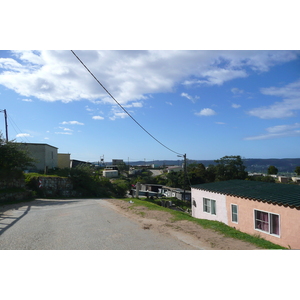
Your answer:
106,199 -> 261,250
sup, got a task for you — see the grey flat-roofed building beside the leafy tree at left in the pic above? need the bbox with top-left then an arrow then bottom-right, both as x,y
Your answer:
19,143 -> 58,171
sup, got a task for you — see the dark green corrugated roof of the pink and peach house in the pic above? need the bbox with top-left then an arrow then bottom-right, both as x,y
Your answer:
191,180 -> 300,208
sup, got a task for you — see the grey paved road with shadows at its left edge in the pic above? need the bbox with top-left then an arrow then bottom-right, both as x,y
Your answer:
0,199 -> 195,250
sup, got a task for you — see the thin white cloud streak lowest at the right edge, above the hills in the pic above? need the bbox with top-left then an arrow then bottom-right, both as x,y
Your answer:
245,123 -> 300,140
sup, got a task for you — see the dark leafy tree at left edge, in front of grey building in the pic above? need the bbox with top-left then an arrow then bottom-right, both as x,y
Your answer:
0,132 -> 35,178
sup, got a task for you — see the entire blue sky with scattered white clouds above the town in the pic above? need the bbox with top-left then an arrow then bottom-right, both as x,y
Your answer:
0,50 -> 300,161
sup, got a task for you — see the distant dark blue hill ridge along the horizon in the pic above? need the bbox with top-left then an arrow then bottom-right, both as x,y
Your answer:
129,158 -> 300,173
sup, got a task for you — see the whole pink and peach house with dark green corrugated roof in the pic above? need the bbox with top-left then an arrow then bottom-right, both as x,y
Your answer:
191,180 -> 300,249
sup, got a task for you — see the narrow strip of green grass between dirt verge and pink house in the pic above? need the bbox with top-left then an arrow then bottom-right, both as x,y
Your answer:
120,198 -> 288,249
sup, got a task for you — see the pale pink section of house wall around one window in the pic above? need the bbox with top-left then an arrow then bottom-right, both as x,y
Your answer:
191,188 -> 228,224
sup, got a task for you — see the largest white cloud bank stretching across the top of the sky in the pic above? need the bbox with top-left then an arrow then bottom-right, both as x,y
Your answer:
0,50 -> 297,107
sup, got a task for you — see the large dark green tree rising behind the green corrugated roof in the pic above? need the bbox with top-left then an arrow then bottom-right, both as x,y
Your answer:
215,155 -> 248,181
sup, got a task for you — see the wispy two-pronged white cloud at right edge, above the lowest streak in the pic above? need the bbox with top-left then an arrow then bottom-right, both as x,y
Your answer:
248,80 -> 300,119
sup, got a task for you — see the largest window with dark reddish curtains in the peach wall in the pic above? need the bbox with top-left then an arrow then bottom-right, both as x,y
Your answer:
254,210 -> 279,235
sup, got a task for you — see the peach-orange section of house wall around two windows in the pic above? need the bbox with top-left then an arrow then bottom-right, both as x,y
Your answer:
226,196 -> 300,249
